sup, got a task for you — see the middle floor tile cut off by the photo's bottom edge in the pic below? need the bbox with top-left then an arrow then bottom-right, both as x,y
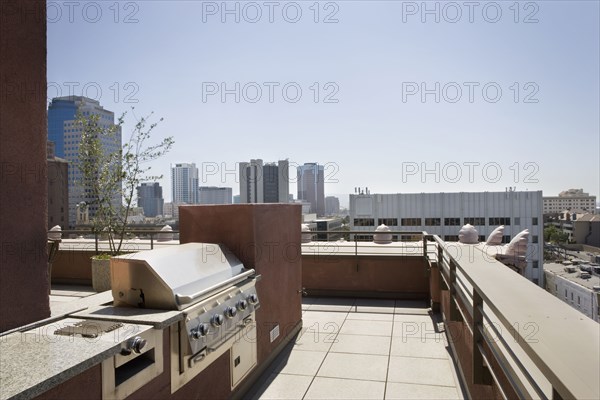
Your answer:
304,377 -> 385,400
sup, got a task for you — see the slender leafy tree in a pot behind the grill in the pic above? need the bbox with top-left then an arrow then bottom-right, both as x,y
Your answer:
76,108 -> 174,291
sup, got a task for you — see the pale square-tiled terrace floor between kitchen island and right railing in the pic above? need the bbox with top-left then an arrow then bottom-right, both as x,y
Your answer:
251,298 -> 463,399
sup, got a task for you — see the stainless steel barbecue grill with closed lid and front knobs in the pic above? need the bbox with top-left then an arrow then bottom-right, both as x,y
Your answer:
111,243 -> 260,392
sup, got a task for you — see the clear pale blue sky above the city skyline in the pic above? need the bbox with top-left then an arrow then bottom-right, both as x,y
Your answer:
47,0 -> 600,204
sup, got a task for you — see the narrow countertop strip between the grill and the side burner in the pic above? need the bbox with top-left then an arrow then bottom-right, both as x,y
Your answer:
71,305 -> 183,329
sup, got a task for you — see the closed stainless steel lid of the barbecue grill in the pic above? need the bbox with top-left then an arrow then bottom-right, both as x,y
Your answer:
110,243 -> 254,310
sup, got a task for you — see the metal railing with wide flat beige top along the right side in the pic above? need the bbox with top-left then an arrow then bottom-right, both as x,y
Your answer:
423,235 -> 600,399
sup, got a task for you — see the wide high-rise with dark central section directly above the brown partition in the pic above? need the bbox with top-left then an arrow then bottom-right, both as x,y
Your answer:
239,159 -> 290,203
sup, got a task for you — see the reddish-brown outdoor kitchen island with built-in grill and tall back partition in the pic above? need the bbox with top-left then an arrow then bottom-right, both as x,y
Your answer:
0,204 -> 302,399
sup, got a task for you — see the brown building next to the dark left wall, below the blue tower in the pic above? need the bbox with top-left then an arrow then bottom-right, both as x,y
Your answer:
46,141 -> 69,229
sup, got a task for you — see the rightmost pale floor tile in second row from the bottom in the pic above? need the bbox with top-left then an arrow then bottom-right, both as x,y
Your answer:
387,356 -> 456,386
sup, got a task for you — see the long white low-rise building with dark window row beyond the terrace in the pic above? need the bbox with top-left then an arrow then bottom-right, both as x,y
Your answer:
350,190 -> 544,285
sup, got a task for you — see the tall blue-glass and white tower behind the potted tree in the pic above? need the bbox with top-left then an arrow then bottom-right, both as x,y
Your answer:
48,96 -> 121,224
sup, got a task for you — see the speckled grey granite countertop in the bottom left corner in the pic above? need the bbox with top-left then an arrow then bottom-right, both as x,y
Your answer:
0,318 -> 152,400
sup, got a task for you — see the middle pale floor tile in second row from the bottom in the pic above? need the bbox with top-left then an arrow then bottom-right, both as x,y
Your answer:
317,353 -> 388,382
